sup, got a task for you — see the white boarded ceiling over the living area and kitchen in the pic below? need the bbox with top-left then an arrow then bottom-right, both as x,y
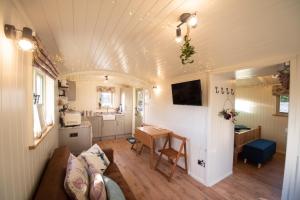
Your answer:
19,0 -> 300,81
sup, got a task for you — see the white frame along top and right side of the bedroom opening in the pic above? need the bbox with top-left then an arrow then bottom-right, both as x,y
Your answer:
213,54 -> 300,200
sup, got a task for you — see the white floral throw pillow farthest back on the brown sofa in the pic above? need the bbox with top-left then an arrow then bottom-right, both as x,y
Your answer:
80,144 -> 110,175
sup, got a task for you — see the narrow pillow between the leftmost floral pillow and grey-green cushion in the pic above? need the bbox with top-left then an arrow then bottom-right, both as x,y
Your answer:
90,173 -> 107,200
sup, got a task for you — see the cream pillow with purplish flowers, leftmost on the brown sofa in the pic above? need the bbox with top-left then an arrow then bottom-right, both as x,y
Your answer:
64,154 -> 89,200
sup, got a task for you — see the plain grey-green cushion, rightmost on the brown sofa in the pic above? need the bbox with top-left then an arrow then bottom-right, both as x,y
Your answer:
103,176 -> 125,200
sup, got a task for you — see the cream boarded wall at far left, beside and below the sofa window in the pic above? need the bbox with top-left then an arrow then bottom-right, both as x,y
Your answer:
0,0 -> 58,200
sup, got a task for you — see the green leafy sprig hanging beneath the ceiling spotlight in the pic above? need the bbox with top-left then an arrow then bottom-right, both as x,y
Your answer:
180,34 -> 196,65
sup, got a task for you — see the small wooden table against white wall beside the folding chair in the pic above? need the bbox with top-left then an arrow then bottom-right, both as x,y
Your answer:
134,126 -> 172,168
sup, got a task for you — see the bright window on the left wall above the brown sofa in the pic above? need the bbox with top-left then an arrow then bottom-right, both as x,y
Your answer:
33,69 -> 54,139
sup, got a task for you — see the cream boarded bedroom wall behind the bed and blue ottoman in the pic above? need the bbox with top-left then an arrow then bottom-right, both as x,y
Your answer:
236,85 -> 288,153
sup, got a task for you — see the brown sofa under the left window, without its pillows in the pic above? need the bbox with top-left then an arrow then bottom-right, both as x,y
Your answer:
33,146 -> 136,200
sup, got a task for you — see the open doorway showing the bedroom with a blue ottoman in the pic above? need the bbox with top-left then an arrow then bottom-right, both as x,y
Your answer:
233,62 -> 290,199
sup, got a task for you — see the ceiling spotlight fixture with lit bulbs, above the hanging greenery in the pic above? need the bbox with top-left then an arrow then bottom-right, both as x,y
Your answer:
175,13 -> 198,43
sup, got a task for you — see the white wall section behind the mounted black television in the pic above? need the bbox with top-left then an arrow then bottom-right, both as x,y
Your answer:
145,74 -> 208,183
